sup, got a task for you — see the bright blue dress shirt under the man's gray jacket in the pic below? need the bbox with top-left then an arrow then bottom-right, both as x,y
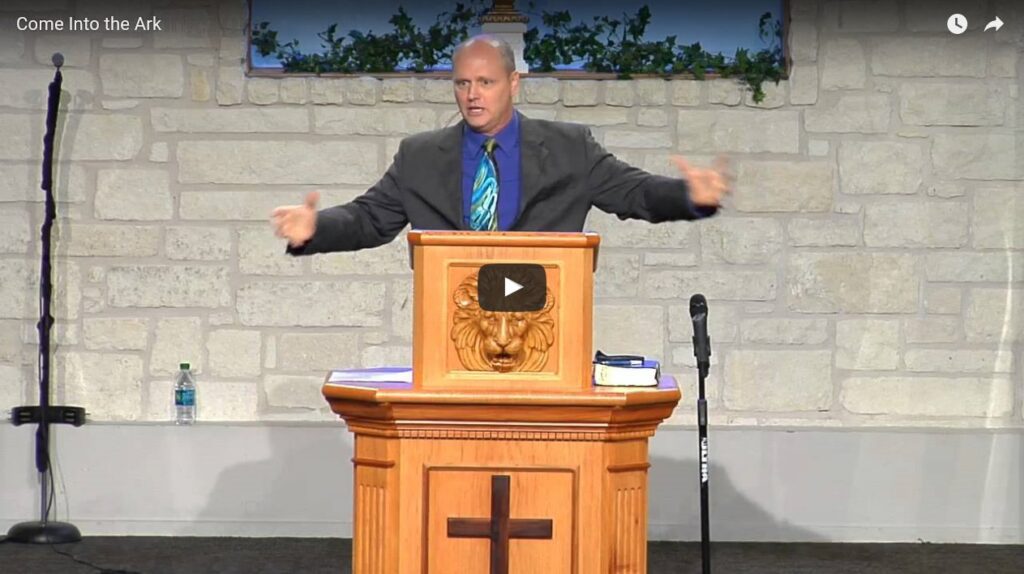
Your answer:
462,112 -> 520,231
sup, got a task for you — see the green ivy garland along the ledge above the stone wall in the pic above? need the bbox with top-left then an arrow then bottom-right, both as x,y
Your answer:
252,0 -> 785,102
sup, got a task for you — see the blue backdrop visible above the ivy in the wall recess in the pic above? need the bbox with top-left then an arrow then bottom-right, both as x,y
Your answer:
253,0 -> 783,68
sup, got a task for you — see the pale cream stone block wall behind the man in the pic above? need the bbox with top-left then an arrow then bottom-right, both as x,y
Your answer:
0,0 -> 1024,427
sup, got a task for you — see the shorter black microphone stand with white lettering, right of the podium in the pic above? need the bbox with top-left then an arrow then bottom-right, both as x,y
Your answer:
690,294 -> 711,574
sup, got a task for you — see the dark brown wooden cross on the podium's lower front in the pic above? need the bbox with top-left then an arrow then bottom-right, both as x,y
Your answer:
449,475 -> 551,574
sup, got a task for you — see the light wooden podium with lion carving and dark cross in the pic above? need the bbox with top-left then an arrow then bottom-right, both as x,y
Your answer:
324,231 -> 680,574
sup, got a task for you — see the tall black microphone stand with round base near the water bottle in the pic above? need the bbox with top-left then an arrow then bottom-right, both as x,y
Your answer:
6,53 -> 85,544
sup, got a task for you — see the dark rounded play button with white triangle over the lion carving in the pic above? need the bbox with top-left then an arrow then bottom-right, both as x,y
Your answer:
477,263 -> 548,312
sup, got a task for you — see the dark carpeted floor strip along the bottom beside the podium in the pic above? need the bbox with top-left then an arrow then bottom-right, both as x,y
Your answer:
0,536 -> 1024,574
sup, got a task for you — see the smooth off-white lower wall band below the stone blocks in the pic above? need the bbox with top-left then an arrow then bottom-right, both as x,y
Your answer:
0,423 -> 1024,543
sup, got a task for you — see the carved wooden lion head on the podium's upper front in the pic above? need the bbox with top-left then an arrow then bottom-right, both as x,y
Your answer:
451,273 -> 555,372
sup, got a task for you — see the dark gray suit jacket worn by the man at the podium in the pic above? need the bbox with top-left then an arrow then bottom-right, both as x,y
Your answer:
288,115 -> 716,255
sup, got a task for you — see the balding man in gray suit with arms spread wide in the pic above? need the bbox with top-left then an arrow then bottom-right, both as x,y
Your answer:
272,36 -> 728,255
